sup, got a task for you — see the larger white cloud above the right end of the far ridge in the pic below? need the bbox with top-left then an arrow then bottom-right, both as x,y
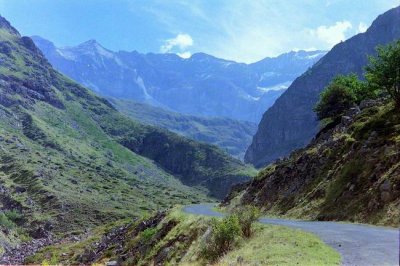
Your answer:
311,20 -> 353,48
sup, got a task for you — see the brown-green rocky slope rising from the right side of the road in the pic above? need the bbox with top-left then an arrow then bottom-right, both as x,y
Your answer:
225,101 -> 400,227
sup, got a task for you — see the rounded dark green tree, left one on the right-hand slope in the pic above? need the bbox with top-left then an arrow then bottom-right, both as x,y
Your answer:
314,77 -> 356,120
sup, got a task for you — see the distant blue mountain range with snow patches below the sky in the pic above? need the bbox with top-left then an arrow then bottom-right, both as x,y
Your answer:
32,36 -> 325,123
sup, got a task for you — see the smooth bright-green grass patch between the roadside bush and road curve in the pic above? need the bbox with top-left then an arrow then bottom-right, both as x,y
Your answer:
217,224 -> 341,266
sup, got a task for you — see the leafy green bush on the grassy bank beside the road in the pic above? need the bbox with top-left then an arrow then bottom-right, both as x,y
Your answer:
201,214 -> 242,262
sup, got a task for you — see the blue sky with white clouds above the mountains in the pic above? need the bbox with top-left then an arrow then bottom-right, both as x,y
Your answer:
0,0 -> 400,63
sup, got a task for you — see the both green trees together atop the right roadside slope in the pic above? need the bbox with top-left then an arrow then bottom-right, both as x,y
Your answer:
314,41 -> 400,120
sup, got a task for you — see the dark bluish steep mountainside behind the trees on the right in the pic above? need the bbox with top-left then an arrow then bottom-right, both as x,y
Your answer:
245,7 -> 400,167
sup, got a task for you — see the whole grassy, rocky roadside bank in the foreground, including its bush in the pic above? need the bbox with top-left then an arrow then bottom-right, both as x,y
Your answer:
28,208 -> 340,266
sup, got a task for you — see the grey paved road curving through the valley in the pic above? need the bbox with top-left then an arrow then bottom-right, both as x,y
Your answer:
184,204 -> 400,266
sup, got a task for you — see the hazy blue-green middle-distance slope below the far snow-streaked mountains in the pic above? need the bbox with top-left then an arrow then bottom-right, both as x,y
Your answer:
109,98 -> 257,159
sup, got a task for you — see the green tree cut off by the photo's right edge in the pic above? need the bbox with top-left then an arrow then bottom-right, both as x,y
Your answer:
365,40 -> 400,108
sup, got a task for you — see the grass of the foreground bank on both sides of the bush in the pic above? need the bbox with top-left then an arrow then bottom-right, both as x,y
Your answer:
27,207 -> 340,266
